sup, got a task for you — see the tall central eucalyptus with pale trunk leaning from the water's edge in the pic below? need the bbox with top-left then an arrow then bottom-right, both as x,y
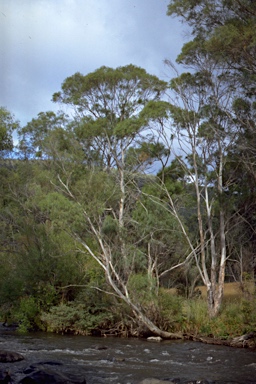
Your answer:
49,65 -> 184,337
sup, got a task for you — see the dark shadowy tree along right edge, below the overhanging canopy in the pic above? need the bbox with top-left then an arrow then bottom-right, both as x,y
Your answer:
227,97 -> 256,286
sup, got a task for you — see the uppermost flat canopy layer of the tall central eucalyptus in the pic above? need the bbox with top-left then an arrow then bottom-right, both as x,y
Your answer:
53,64 -> 166,108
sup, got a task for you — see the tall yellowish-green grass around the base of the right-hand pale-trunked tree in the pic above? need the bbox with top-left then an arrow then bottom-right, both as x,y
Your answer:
165,282 -> 256,339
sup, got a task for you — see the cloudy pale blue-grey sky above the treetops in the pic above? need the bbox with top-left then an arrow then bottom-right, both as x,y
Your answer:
0,0 -> 186,125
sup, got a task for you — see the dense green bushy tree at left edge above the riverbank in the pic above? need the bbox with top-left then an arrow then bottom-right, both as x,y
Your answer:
0,154 -> 92,329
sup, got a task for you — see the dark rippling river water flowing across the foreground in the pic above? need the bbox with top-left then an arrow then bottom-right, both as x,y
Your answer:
0,330 -> 256,384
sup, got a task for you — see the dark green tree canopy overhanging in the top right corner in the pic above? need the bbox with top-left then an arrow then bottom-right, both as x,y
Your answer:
167,0 -> 256,79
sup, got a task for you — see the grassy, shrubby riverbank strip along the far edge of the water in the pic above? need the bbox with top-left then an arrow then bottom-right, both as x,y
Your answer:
1,282 -> 256,349
